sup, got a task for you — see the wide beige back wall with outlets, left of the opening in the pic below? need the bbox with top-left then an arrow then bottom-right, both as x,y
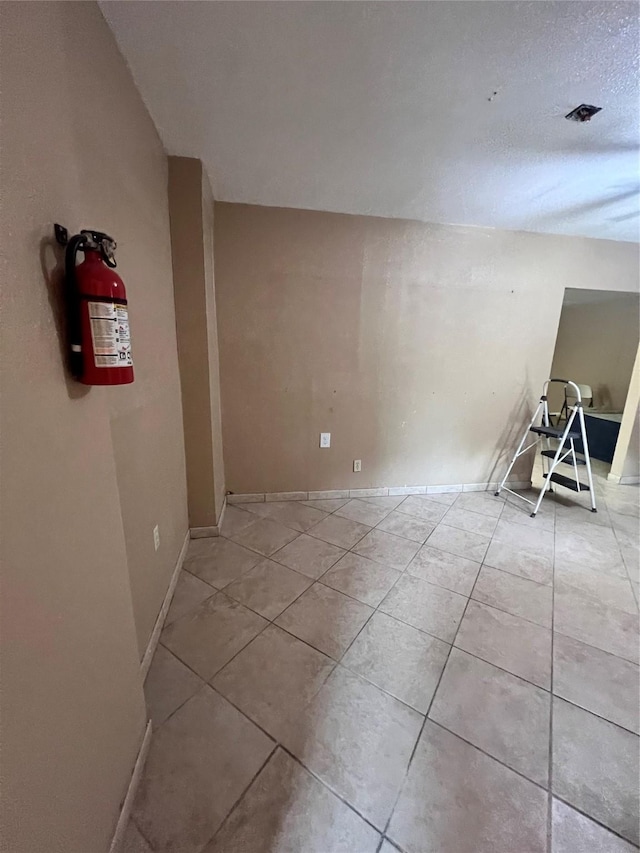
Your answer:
215,204 -> 638,492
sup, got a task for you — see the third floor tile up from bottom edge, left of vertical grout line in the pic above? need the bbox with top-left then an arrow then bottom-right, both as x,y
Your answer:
455,601 -> 551,690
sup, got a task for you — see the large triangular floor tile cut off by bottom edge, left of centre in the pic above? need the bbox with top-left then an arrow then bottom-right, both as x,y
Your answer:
203,749 -> 380,853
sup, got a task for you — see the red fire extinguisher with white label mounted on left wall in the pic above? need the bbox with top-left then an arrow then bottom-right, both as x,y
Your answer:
55,225 -> 133,385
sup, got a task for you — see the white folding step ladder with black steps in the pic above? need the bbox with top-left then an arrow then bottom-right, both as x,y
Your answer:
496,379 -> 598,518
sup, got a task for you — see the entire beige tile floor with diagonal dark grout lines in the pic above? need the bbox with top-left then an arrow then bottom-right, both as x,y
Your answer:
125,462 -> 640,853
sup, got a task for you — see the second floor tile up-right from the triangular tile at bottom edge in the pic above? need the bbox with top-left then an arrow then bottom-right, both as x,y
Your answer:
342,613 -> 450,714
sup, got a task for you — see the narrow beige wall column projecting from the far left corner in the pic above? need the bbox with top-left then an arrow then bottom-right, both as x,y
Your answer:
169,157 -> 225,528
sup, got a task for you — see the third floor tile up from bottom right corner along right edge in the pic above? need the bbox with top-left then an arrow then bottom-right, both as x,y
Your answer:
553,634 -> 640,733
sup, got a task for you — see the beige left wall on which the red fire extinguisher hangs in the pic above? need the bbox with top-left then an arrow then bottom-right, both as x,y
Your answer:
0,2 -> 187,853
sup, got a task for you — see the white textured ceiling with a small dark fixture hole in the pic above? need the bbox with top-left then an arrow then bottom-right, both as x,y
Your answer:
101,0 -> 640,240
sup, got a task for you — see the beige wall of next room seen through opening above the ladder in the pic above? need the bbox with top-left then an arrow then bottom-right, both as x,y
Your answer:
551,294 -> 640,412
